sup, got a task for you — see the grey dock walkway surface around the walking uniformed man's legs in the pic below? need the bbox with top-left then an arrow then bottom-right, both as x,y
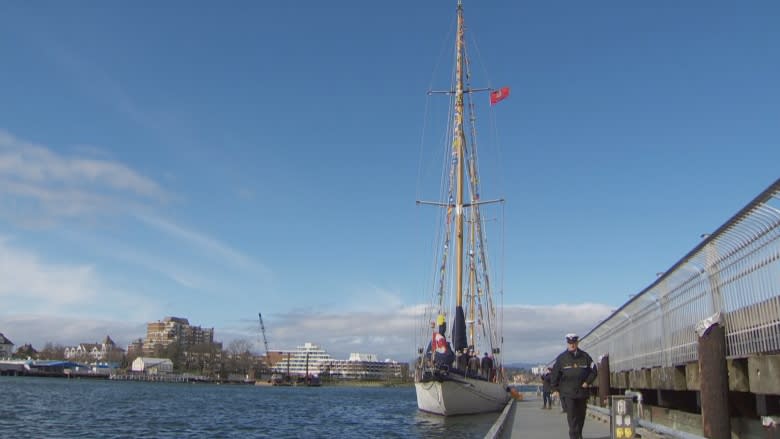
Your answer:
500,397 -> 610,439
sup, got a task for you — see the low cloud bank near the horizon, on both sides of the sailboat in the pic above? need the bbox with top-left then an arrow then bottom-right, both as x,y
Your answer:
215,303 -> 613,363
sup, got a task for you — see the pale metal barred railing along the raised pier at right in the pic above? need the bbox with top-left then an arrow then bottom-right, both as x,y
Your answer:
580,179 -> 780,372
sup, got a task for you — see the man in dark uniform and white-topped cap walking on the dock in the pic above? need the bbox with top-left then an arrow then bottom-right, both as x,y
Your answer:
551,334 -> 597,439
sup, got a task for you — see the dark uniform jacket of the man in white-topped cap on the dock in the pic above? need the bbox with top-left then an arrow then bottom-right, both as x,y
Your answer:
551,349 -> 598,398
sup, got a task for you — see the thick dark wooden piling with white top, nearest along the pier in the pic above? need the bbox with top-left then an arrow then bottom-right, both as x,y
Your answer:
696,314 -> 731,439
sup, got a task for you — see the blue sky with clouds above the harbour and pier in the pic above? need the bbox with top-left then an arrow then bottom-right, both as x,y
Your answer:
0,0 -> 780,361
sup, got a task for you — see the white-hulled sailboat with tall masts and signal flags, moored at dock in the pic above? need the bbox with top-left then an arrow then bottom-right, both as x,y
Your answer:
415,0 -> 510,416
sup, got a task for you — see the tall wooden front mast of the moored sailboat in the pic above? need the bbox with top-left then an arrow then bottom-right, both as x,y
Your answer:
452,0 -> 466,306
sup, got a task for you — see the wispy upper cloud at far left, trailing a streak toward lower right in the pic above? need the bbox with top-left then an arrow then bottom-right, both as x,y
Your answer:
0,129 -> 270,287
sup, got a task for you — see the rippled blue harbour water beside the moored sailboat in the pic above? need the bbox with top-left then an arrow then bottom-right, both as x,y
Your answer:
0,377 -> 499,439
